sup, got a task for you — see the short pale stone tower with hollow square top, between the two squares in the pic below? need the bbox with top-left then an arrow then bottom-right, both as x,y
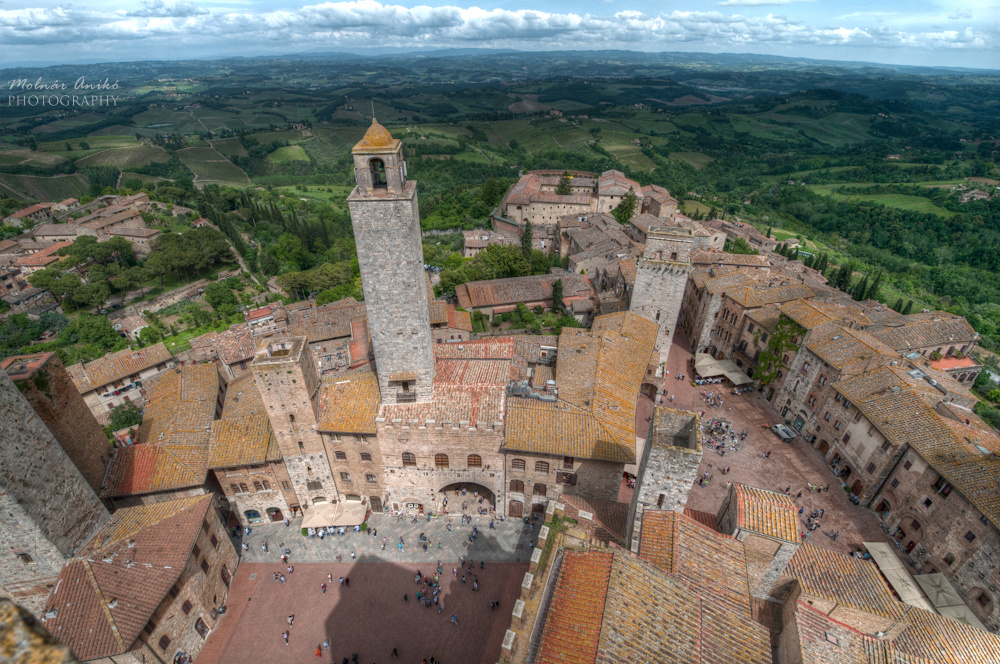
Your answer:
625,406 -> 702,553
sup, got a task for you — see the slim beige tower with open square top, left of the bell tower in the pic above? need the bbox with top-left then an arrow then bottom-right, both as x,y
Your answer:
250,337 -> 340,508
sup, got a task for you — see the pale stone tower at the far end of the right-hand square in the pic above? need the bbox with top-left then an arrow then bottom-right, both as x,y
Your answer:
629,226 -> 694,378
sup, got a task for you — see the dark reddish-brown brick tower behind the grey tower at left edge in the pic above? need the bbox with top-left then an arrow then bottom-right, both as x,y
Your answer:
0,353 -> 111,492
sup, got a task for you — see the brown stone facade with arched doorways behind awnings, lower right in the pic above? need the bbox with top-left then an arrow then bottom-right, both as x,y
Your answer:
871,448 -> 1000,633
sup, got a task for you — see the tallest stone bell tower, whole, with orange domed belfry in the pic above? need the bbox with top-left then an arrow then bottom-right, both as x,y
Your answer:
347,118 -> 434,404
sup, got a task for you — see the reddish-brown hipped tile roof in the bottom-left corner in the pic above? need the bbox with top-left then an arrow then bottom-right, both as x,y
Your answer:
45,496 -> 212,660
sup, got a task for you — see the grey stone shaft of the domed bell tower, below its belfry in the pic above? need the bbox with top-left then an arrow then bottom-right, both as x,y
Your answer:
347,181 -> 434,404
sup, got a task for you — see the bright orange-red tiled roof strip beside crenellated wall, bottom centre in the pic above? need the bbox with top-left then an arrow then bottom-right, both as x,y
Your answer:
535,551 -> 614,664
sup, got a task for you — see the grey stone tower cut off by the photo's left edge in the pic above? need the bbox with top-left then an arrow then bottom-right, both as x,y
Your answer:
0,371 -> 108,615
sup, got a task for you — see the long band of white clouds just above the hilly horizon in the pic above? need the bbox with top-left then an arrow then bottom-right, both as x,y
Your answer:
0,0 -> 1000,62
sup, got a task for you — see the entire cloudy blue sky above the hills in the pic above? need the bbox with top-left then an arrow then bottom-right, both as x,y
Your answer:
0,0 -> 1000,69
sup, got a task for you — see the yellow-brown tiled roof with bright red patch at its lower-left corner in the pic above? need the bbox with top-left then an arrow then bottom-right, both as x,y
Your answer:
101,364 -> 219,497
